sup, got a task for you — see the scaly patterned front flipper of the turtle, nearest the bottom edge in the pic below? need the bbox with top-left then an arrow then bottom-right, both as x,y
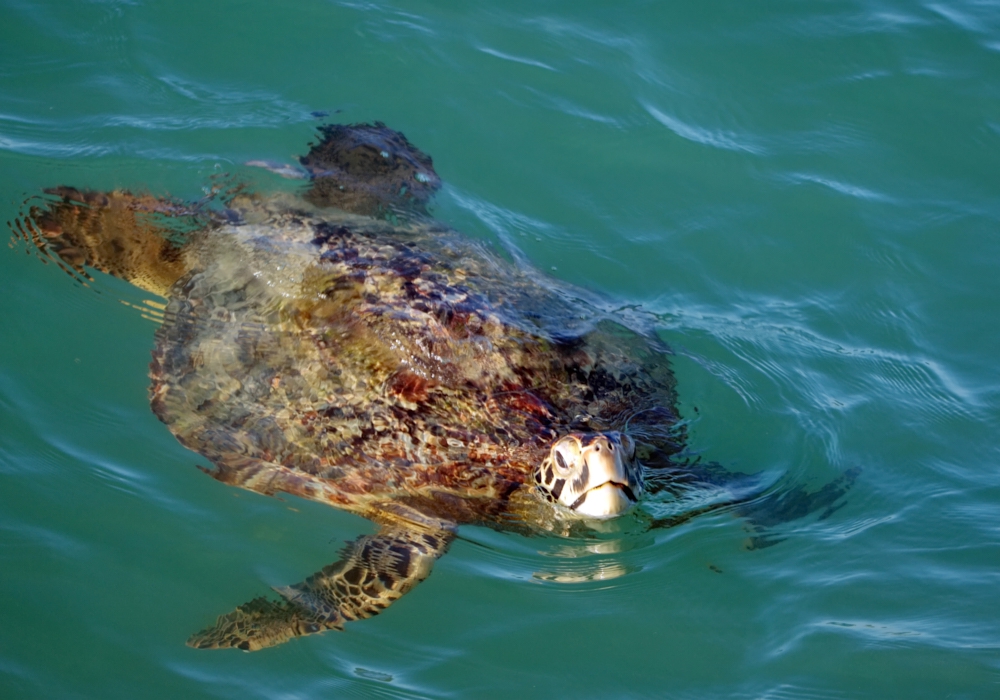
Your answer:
187,524 -> 454,651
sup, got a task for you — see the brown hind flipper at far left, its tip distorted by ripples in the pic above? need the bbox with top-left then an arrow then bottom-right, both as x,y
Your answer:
11,187 -> 207,296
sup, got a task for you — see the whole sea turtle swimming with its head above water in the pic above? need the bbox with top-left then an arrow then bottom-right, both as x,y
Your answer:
12,123 -> 852,650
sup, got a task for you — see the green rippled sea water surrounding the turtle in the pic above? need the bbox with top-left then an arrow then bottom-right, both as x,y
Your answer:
0,0 -> 1000,698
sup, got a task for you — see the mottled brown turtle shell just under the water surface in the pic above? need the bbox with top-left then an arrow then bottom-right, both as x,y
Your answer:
151,201 -> 676,521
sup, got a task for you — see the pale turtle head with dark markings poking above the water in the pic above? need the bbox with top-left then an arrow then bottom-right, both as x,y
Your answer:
535,432 -> 642,518
